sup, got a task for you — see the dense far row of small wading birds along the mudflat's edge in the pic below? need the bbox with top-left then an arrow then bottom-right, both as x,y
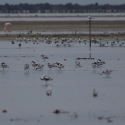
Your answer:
11,37 -> 125,48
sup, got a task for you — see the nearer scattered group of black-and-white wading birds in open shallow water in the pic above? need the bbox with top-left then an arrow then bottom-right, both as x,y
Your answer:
0,60 -> 113,97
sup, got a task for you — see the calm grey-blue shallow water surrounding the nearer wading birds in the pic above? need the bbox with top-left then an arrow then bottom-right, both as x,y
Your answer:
0,41 -> 125,125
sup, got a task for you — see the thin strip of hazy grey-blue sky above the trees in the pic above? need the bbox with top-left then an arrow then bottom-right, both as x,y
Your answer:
0,0 -> 125,5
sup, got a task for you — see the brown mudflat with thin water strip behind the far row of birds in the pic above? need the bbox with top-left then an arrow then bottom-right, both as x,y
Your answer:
0,20 -> 125,38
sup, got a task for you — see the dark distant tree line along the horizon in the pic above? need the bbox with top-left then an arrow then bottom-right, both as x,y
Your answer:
0,3 -> 125,13
